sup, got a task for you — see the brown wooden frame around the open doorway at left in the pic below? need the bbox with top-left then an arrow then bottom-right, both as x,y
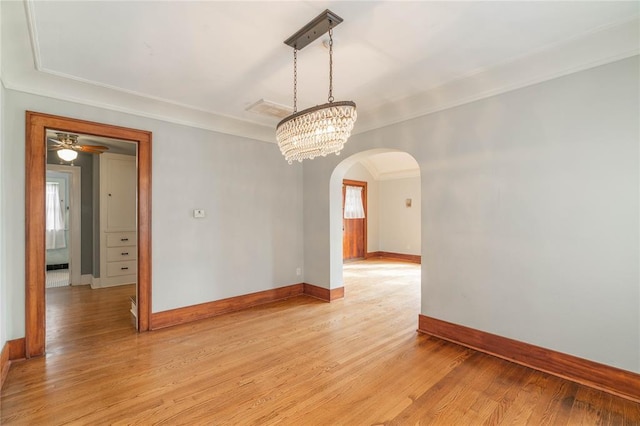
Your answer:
25,111 -> 151,358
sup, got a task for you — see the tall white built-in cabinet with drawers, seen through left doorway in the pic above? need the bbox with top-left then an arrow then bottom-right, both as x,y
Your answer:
100,153 -> 138,287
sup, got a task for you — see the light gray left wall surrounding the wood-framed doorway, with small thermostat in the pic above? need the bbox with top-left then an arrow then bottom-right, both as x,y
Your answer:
0,90 -> 303,332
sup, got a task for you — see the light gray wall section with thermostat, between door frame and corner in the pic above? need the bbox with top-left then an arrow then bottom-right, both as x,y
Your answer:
147,119 -> 303,312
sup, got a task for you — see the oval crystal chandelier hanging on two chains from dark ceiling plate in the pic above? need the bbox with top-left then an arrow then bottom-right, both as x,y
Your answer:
276,10 -> 358,164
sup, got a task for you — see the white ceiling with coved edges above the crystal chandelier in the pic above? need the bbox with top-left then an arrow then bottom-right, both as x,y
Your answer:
0,0 -> 640,147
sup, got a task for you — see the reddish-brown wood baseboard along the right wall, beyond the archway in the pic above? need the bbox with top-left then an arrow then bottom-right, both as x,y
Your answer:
418,315 -> 640,402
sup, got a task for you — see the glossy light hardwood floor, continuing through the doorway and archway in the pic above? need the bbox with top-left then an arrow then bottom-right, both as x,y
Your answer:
0,260 -> 640,425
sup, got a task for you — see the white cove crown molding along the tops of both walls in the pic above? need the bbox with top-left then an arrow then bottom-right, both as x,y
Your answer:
2,0 -> 640,145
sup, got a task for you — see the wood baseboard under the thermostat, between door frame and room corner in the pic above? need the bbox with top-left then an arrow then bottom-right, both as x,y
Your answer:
151,284 -> 304,330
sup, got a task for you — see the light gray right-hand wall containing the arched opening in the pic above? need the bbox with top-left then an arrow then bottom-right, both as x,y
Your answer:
303,56 -> 640,372
